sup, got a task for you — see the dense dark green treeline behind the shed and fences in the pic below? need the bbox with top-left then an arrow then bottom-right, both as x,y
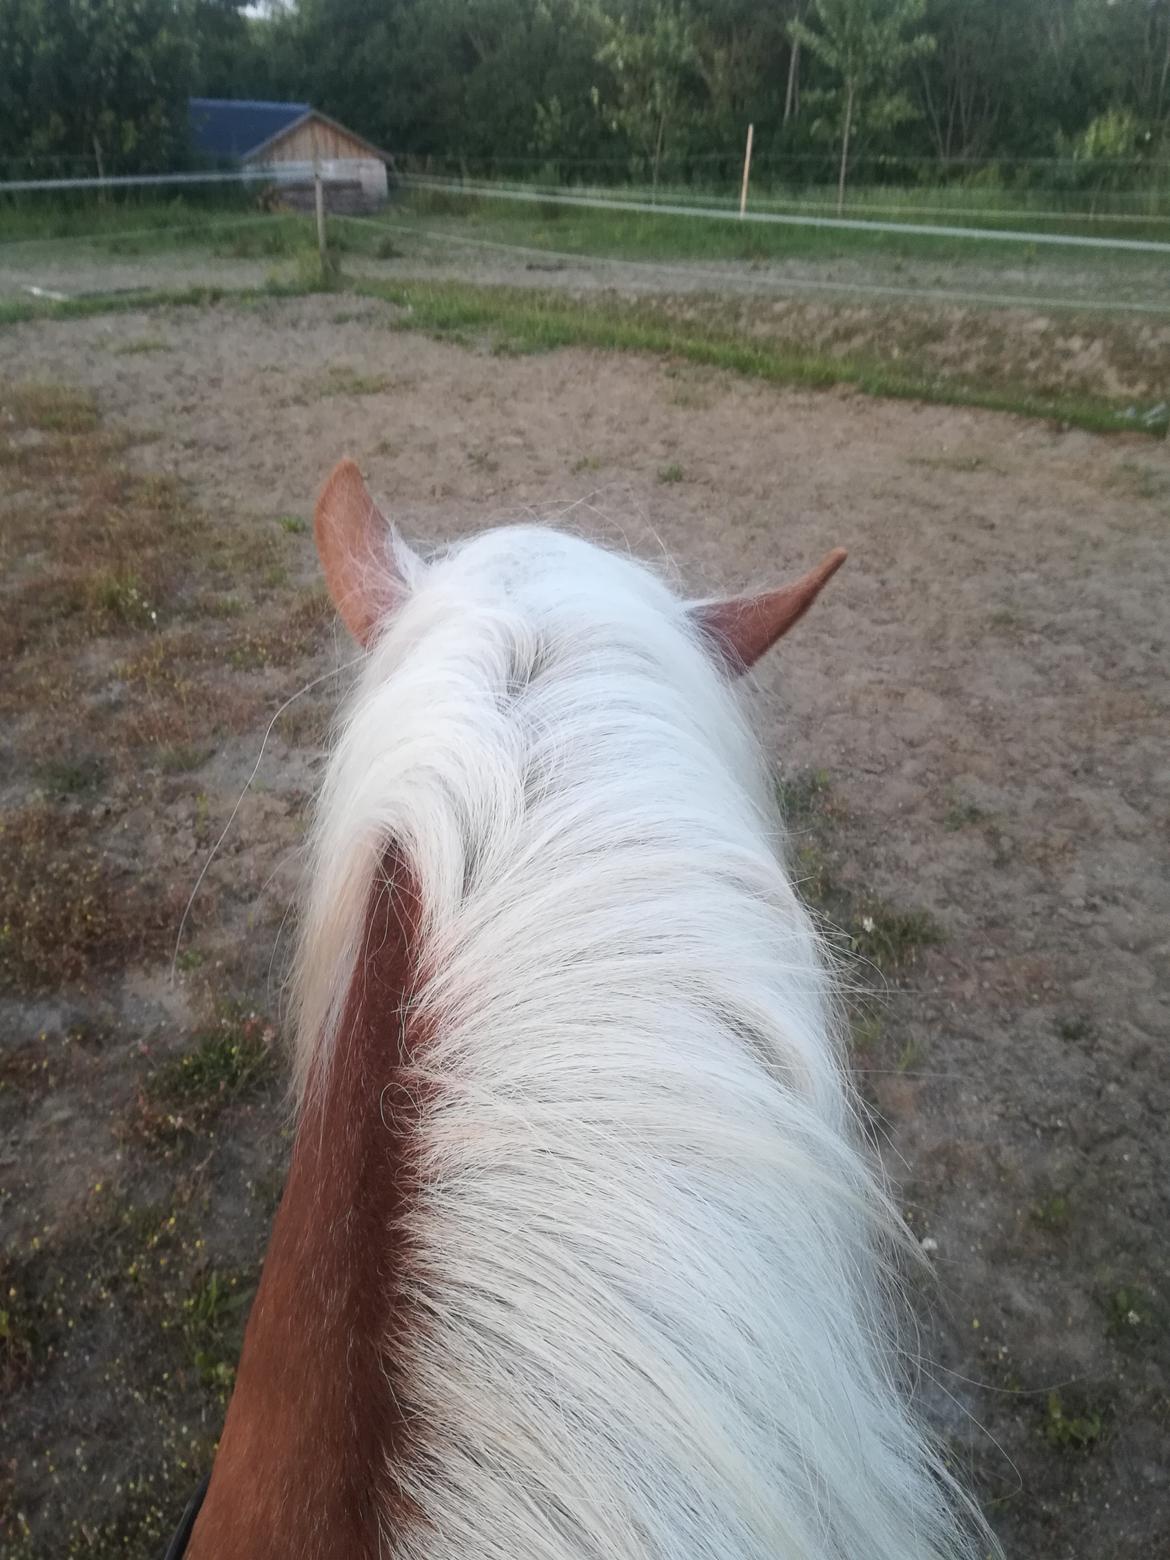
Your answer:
0,0 -> 1170,183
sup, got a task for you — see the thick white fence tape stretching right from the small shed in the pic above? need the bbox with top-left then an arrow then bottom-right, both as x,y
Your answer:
399,173 -> 1170,254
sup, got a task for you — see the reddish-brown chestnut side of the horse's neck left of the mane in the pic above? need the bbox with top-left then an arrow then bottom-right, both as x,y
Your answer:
189,860 -> 418,1560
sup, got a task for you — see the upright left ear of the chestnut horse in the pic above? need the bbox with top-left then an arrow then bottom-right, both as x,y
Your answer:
314,460 -> 407,644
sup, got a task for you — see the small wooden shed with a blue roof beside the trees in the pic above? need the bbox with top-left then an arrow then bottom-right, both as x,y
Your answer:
187,98 -> 393,212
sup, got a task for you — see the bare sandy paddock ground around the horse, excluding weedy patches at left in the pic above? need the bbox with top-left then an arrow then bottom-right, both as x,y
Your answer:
0,298 -> 1170,1560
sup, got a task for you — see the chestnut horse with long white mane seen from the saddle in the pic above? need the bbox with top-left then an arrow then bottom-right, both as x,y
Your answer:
175,462 -> 995,1560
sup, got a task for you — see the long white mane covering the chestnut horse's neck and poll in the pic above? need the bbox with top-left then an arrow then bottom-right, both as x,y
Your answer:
288,527 -> 994,1560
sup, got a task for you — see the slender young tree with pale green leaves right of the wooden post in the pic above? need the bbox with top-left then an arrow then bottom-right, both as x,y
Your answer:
791,0 -> 934,212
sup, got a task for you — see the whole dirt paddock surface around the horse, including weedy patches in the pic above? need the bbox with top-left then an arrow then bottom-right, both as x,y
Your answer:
0,296 -> 1170,1560
